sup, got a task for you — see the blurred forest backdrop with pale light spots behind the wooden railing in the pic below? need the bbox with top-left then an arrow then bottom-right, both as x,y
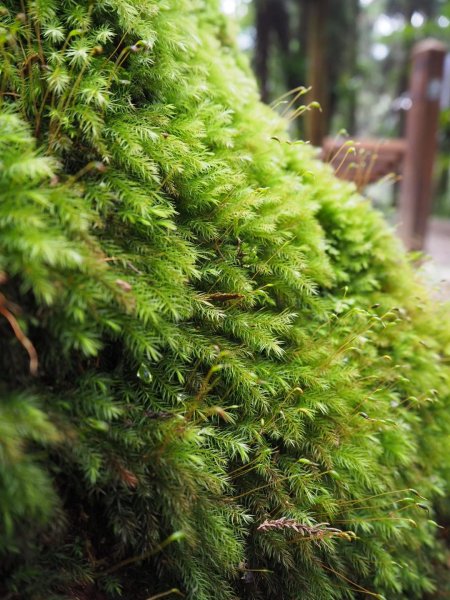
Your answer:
221,0 -> 450,286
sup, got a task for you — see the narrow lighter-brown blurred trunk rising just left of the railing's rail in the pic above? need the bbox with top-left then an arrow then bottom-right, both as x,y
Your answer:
306,0 -> 329,146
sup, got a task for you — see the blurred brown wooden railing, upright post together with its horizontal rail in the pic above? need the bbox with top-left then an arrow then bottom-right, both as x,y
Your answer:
322,40 -> 450,250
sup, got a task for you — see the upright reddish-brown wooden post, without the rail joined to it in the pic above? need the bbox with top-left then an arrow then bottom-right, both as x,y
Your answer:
399,39 -> 446,250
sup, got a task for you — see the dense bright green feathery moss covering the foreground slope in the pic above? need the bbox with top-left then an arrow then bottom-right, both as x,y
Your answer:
0,0 -> 450,600
